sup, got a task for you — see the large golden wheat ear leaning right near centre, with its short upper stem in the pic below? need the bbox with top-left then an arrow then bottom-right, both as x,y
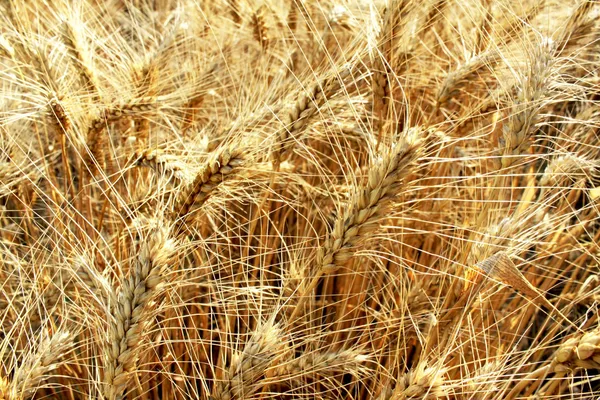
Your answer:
290,129 -> 421,321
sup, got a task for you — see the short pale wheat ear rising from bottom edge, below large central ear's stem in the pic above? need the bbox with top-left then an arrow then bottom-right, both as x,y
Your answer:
211,321 -> 283,400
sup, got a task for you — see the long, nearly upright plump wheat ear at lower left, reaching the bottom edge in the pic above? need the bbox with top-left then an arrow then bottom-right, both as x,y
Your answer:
103,228 -> 175,400
